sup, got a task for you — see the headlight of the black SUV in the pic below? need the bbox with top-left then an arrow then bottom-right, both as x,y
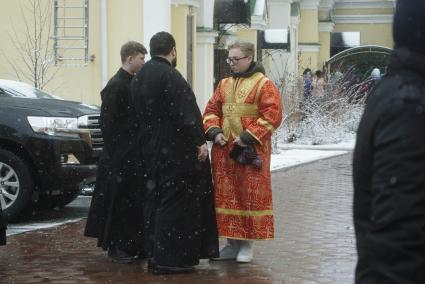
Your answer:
28,116 -> 90,140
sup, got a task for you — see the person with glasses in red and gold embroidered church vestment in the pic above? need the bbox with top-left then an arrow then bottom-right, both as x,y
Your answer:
204,40 -> 282,262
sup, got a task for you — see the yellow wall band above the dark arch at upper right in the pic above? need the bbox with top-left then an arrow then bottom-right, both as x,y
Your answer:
334,24 -> 394,48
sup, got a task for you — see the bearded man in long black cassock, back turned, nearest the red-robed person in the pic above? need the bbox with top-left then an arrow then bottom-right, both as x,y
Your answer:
131,32 -> 218,274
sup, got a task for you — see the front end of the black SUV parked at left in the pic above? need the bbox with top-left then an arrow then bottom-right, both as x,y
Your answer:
0,80 -> 103,220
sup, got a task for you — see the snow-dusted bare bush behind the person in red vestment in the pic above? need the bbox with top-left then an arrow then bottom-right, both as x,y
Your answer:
273,73 -> 370,146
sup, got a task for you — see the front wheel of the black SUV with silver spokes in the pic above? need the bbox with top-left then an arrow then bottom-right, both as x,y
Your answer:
0,149 -> 33,220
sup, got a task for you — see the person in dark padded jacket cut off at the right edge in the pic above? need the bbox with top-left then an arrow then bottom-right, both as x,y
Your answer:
353,0 -> 425,284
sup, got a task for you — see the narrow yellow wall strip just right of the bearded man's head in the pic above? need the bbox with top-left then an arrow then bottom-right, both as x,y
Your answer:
171,5 -> 189,78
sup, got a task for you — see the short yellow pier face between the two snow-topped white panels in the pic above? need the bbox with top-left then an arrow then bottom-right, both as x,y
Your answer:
298,10 -> 319,43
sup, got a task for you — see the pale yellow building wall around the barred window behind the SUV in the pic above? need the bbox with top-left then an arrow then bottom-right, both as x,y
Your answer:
0,0 -> 147,105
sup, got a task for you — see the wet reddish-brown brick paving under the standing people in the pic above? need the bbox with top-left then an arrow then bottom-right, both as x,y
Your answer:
0,155 -> 356,284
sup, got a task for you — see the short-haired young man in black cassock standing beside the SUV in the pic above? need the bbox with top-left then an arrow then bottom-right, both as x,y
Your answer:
85,41 -> 147,263
